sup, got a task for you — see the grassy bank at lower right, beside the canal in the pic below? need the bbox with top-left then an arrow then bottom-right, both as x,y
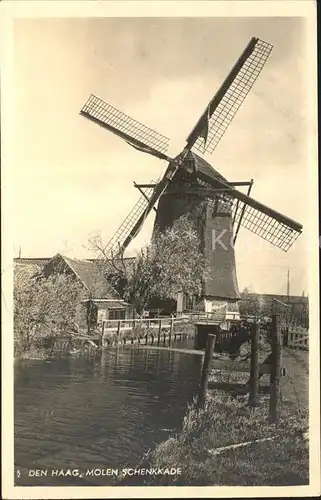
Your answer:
117,391 -> 309,486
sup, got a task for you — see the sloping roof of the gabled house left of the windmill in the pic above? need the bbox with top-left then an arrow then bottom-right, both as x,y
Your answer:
43,253 -> 121,300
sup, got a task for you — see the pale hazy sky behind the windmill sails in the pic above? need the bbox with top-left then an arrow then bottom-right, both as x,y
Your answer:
12,17 -> 311,295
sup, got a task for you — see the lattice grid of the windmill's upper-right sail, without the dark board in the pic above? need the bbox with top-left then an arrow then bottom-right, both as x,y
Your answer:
193,39 -> 273,154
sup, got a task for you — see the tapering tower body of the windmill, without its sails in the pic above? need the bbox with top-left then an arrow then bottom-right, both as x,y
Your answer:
154,153 -> 240,313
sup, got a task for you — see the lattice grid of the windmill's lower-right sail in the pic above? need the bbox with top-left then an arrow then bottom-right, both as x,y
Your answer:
232,199 -> 301,252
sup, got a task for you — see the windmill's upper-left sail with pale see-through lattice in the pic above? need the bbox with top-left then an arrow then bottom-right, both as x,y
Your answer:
80,94 -> 170,161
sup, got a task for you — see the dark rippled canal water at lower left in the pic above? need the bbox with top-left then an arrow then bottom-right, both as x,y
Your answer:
15,340 -> 202,486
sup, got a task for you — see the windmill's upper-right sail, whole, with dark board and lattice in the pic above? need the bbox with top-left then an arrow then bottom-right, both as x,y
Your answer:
186,37 -> 273,153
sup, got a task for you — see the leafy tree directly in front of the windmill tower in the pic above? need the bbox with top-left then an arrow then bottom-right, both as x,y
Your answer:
90,216 -> 208,315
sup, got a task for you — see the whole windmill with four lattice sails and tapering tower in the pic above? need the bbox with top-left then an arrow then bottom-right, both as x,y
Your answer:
80,37 -> 302,311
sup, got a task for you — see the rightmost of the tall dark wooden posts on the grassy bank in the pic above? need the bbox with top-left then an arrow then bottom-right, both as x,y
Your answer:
269,313 -> 281,424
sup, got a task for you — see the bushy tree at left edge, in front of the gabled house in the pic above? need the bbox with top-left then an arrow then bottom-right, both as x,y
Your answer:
13,268 -> 81,351
